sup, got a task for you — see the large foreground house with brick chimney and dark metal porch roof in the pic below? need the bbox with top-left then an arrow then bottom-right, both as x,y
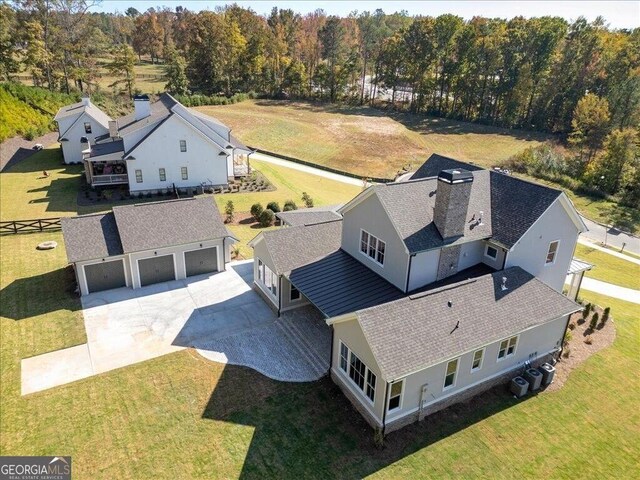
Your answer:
250,155 -> 586,432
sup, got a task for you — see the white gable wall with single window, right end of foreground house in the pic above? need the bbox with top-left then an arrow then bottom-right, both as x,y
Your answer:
505,200 -> 578,292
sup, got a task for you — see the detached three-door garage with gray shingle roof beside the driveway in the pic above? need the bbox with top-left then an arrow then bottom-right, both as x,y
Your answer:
62,197 -> 236,295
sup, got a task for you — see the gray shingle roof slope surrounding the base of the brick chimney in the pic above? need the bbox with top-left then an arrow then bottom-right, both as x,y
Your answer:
372,170 -> 492,253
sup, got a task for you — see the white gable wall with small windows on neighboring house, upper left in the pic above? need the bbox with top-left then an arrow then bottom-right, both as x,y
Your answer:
127,115 -> 228,191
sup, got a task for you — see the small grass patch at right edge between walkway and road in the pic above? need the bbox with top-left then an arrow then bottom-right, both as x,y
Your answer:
575,244 -> 640,290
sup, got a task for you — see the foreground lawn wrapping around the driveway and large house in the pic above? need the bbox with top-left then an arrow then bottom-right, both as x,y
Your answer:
0,233 -> 640,479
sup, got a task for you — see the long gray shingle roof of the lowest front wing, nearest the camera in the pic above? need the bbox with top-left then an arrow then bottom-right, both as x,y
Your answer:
356,267 -> 580,381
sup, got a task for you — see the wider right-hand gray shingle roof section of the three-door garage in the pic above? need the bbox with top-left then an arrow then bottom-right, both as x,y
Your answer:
113,198 -> 231,253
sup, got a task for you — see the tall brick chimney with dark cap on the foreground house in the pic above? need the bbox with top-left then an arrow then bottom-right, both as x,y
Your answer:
433,168 -> 473,240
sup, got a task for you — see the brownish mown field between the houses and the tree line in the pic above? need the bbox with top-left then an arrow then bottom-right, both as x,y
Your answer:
198,100 -> 551,178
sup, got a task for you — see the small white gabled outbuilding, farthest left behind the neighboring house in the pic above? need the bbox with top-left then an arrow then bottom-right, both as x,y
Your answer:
53,96 -> 112,163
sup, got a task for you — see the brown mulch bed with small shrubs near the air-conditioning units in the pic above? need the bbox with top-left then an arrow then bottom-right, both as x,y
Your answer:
545,306 -> 616,392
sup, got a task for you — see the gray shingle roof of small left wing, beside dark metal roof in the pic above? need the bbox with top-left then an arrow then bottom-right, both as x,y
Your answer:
262,220 -> 342,274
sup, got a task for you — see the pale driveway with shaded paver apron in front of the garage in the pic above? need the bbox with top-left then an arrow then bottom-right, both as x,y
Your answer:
22,261 -> 329,395
